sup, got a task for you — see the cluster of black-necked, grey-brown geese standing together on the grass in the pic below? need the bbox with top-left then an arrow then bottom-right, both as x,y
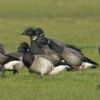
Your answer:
0,28 -> 98,76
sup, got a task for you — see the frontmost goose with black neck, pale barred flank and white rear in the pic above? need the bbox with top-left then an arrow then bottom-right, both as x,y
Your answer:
20,42 -> 68,75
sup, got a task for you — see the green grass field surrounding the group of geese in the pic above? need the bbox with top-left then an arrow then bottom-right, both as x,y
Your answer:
0,0 -> 100,100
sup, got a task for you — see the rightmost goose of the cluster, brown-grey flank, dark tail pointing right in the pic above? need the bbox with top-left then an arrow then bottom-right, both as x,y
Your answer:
23,28 -> 98,70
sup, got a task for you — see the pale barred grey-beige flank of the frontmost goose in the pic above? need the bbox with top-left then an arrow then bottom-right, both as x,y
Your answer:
30,55 -> 54,75
